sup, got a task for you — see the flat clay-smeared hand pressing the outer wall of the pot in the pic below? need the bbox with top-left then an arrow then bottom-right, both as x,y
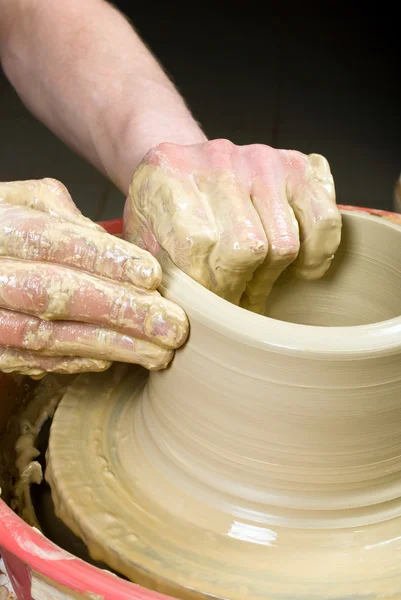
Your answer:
0,179 -> 188,376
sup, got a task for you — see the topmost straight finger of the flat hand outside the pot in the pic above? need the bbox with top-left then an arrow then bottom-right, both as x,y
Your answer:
0,203 -> 162,290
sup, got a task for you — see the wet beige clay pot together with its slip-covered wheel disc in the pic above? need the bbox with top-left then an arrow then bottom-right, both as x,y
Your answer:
46,214 -> 401,600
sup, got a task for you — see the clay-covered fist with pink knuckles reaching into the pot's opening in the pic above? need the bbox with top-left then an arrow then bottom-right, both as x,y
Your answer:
124,140 -> 341,313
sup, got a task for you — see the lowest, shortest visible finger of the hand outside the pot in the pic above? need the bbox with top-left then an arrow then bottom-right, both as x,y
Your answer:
0,347 -> 111,379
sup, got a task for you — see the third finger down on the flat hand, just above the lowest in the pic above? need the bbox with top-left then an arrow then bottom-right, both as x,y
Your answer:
0,309 -> 173,371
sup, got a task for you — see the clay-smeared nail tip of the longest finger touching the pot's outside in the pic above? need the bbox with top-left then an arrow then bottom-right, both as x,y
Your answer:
145,300 -> 189,349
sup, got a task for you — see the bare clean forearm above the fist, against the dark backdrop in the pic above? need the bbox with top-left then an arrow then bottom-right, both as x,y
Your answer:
0,0 -> 205,193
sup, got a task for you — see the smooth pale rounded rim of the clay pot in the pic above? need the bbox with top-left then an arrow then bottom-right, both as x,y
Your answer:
157,211 -> 401,359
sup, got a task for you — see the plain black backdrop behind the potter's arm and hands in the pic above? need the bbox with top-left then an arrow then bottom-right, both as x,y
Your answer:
0,1 -> 401,219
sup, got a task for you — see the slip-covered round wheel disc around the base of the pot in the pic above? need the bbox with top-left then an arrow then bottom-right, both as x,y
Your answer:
46,360 -> 401,600
